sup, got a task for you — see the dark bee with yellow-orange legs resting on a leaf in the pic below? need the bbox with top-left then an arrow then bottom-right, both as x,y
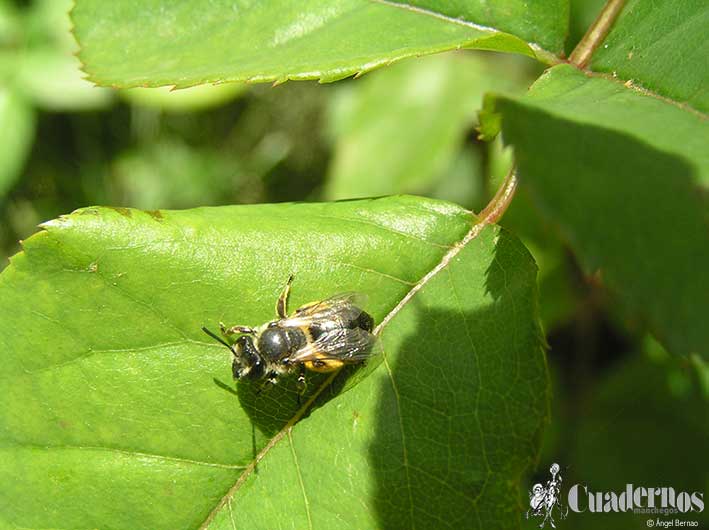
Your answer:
202,275 -> 377,393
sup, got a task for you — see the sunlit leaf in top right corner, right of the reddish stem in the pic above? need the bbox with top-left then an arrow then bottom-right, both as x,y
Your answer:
591,0 -> 709,112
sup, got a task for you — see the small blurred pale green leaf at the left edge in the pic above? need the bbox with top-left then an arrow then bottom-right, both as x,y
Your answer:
0,86 -> 35,199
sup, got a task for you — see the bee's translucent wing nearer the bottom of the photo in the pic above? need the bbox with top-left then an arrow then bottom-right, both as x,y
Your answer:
288,328 -> 379,363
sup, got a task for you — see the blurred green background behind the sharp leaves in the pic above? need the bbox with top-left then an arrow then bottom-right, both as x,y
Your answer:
0,0 -> 709,528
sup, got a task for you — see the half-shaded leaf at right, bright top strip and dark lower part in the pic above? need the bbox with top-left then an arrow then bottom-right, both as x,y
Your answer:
488,66 -> 709,356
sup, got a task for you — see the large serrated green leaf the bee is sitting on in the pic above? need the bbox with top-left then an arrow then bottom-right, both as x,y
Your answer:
0,196 -> 547,529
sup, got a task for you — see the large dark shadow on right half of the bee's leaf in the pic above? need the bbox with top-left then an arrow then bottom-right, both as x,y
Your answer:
362,243 -> 548,529
